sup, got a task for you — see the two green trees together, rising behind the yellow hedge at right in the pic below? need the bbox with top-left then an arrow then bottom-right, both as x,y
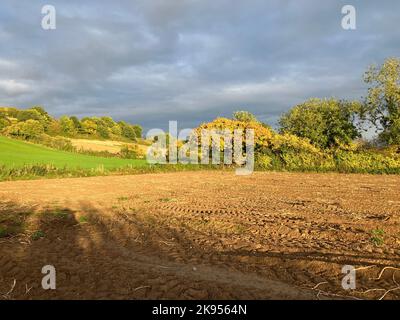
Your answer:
279,58 -> 400,148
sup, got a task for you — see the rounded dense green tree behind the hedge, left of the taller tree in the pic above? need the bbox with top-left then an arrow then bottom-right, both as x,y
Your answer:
279,98 -> 361,148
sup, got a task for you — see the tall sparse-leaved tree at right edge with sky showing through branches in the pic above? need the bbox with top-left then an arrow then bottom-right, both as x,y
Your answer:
363,58 -> 400,144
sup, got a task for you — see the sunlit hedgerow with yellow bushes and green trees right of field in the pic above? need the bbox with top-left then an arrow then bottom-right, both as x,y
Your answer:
196,58 -> 400,174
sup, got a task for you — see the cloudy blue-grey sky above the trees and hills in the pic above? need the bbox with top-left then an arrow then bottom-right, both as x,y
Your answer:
0,0 -> 400,130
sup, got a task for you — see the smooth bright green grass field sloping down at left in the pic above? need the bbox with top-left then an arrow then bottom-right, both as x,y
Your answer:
0,136 -> 147,170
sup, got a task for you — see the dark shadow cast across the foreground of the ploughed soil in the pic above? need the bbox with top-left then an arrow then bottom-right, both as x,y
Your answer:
0,202 -> 399,299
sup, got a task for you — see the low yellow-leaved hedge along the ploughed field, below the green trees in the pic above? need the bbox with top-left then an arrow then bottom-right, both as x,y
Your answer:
190,118 -> 400,173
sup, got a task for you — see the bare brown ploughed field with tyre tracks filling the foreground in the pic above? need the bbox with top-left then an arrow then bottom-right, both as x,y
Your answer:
0,171 -> 400,299
